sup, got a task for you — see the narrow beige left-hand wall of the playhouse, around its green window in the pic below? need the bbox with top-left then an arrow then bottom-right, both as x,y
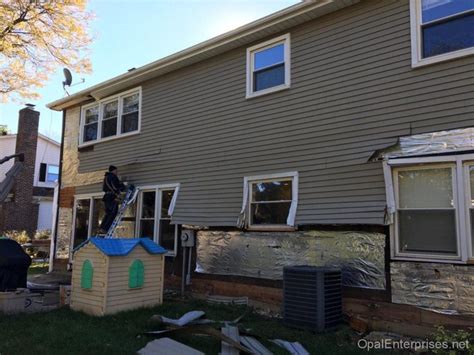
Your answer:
71,244 -> 107,316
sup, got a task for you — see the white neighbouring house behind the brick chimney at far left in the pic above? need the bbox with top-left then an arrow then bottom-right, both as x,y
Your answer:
0,112 -> 60,234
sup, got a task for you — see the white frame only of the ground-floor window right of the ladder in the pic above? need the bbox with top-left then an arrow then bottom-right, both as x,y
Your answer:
135,183 -> 180,257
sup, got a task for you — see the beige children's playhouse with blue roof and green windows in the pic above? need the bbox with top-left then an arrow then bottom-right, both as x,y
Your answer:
70,238 -> 166,316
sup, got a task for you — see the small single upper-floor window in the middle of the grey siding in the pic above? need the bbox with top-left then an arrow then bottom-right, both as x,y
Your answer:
247,34 -> 290,98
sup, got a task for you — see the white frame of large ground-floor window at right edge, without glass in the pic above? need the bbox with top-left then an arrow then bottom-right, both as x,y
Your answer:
385,154 -> 474,264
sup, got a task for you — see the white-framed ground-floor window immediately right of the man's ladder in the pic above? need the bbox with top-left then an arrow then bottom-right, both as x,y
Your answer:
137,184 -> 179,256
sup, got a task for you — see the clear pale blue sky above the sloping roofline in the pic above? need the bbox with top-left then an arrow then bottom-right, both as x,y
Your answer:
0,0 -> 299,140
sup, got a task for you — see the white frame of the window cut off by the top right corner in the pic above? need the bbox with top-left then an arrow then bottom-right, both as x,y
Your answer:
410,0 -> 474,68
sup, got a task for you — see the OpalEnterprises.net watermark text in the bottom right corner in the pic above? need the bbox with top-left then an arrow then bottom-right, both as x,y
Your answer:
357,338 -> 470,351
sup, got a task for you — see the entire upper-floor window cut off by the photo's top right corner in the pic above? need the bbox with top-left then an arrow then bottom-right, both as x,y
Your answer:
410,0 -> 474,67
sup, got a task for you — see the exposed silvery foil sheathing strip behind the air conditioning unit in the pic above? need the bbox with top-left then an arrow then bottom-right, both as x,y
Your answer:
196,231 -> 386,289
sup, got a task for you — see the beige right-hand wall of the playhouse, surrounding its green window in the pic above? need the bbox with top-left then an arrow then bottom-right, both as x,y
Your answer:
106,247 -> 164,314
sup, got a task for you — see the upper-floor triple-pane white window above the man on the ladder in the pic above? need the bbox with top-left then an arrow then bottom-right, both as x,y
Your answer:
80,88 -> 141,145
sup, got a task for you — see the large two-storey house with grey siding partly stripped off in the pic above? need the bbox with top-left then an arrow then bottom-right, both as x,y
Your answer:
49,0 -> 474,322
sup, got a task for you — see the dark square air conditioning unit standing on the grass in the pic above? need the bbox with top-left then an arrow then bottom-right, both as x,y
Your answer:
283,266 -> 342,332
